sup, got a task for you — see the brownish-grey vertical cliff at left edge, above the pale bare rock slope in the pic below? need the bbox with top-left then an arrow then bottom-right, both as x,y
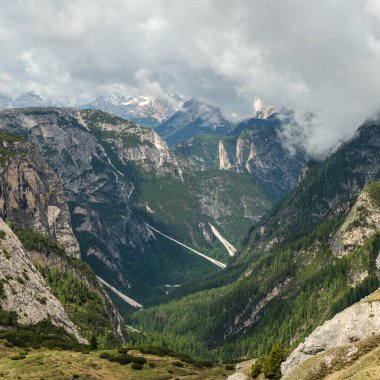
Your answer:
0,139 -> 80,257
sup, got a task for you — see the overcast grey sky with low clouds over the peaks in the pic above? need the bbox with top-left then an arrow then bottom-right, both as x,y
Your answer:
0,0 -> 380,154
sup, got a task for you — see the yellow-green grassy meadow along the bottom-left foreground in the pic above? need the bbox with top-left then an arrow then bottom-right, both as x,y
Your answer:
0,346 -> 231,380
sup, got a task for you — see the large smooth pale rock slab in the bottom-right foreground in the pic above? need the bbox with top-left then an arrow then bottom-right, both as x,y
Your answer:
281,290 -> 380,379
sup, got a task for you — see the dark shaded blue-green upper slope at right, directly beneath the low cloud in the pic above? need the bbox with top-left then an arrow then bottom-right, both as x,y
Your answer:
248,120 -> 380,246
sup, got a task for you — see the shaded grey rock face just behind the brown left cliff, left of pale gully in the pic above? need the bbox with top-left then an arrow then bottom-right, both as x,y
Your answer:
0,108 -> 150,286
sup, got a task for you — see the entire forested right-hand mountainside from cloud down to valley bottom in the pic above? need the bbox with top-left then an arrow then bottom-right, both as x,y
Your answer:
129,123 -> 380,358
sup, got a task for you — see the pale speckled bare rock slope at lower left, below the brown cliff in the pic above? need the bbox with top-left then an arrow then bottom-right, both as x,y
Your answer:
0,219 -> 88,343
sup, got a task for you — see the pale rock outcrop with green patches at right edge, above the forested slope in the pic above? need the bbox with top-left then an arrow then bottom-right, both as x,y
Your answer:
330,185 -> 380,257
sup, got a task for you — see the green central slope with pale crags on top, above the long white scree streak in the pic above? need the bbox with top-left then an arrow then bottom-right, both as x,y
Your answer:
82,111 -> 271,258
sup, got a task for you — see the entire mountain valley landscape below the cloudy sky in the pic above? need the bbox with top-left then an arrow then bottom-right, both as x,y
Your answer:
0,92 -> 380,380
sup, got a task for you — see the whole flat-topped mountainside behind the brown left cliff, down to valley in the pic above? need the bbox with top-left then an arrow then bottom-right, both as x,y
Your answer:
0,108 -> 282,305
